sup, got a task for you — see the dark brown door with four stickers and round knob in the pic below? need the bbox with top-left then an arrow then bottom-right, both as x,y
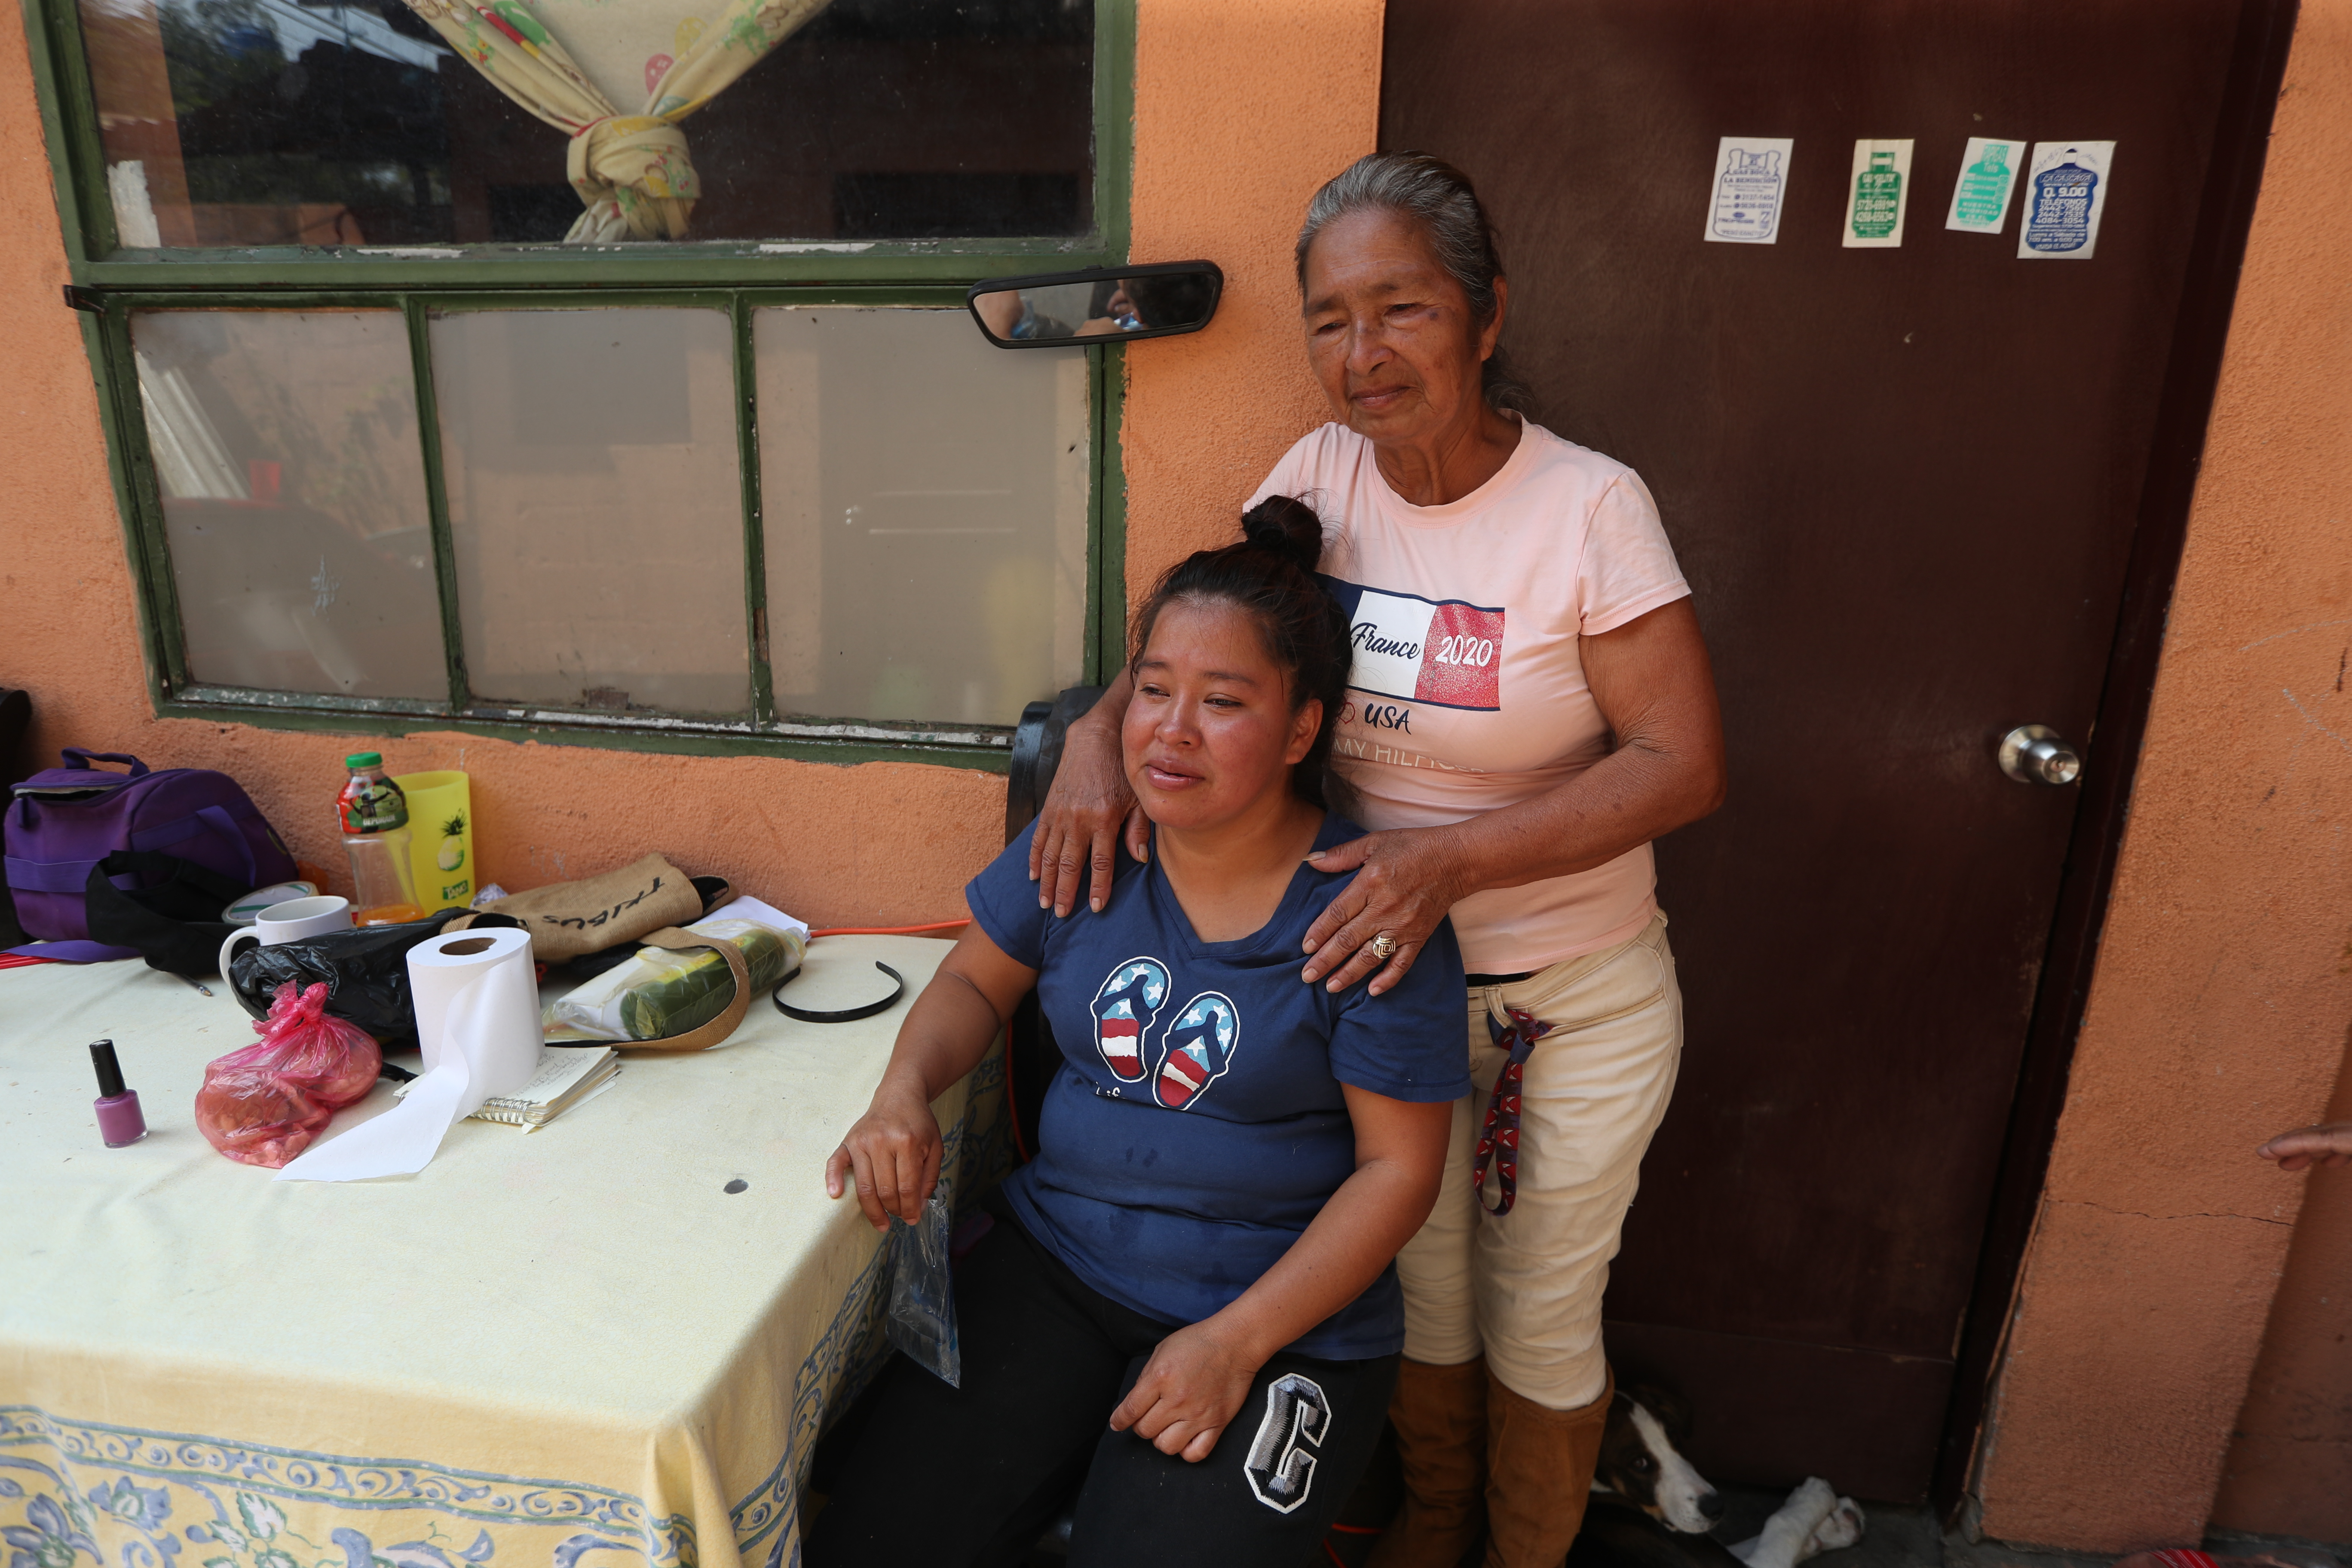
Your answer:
1381,0 -> 2267,1500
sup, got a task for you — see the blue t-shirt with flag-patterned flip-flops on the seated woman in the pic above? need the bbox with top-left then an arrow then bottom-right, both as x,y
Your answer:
965,816 -> 1470,1361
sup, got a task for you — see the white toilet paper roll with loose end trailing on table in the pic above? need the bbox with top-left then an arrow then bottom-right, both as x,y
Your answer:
275,931 -> 541,1182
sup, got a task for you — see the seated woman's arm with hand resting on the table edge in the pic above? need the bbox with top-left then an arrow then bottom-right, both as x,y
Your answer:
826,924 -> 1044,1246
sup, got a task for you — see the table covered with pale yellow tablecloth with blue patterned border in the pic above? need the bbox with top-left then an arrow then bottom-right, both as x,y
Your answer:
0,936 -> 1007,1568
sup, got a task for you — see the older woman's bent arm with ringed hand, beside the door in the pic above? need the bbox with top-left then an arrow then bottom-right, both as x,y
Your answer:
1301,600 -> 1724,992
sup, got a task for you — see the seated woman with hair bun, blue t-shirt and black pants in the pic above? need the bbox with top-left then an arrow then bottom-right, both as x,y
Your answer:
807,496 -> 1470,1568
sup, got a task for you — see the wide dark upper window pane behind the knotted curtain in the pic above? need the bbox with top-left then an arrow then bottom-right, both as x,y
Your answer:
80,0 -> 1093,247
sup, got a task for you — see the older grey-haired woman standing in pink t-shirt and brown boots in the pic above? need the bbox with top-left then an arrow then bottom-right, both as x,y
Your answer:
1030,153 -> 1724,1568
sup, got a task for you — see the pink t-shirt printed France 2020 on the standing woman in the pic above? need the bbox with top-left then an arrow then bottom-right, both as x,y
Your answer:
1251,423 -> 1691,973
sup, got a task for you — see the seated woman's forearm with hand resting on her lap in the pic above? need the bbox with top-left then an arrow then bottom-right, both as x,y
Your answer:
1110,1084 -> 1454,1464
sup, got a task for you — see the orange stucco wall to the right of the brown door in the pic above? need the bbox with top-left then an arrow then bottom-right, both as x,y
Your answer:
1978,0 -> 2352,1552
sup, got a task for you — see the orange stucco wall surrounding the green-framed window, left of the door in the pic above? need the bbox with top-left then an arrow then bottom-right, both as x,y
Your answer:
0,0 -> 1381,924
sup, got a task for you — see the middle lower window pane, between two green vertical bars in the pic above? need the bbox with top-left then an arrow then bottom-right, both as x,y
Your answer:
433,308 -> 750,712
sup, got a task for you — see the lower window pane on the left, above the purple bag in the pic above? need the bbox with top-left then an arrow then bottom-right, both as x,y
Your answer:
132,310 -> 449,703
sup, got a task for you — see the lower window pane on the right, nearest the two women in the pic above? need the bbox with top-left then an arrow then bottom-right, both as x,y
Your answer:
753,308 -> 1087,724
